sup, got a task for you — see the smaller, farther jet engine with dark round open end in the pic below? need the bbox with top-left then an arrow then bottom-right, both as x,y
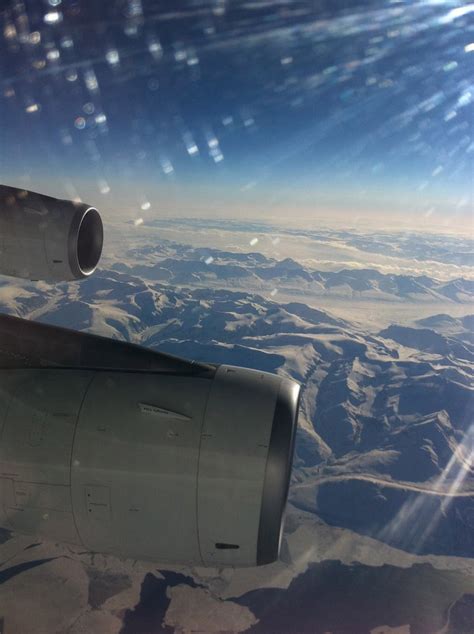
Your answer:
0,185 -> 103,282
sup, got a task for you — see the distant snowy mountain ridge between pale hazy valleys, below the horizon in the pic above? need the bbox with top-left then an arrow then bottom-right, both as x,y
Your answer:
113,241 -> 474,303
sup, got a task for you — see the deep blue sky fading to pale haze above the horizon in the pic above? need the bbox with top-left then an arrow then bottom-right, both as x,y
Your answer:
0,0 -> 474,227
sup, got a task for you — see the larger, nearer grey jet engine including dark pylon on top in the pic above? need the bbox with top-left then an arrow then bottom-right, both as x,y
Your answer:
0,316 -> 300,566
